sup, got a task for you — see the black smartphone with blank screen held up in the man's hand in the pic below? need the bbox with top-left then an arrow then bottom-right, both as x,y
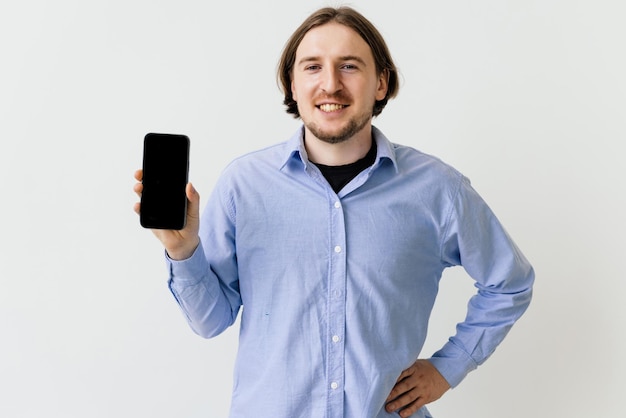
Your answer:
139,133 -> 190,230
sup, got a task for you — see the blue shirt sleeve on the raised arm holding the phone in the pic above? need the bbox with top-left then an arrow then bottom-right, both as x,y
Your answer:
166,180 -> 241,338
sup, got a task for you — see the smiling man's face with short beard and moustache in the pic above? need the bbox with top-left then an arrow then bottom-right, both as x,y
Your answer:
291,23 -> 387,143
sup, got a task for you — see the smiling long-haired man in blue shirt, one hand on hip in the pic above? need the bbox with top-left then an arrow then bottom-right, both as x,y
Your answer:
135,7 -> 534,418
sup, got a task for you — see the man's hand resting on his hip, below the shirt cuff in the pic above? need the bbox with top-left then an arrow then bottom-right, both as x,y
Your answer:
386,360 -> 450,417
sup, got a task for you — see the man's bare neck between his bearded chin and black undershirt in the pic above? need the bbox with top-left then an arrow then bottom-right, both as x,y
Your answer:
304,126 -> 373,166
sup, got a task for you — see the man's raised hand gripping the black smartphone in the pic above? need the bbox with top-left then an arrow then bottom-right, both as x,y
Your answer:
133,170 -> 200,260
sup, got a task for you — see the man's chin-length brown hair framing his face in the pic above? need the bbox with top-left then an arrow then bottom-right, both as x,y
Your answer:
277,6 -> 399,118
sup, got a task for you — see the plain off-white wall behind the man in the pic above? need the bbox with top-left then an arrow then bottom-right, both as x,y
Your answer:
0,0 -> 626,418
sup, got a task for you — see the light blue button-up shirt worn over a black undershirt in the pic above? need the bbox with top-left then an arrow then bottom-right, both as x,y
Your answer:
168,128 -> 534,418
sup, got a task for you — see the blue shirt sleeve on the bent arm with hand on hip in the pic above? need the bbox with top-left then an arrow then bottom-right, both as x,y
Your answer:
430,177 -> 534,387
